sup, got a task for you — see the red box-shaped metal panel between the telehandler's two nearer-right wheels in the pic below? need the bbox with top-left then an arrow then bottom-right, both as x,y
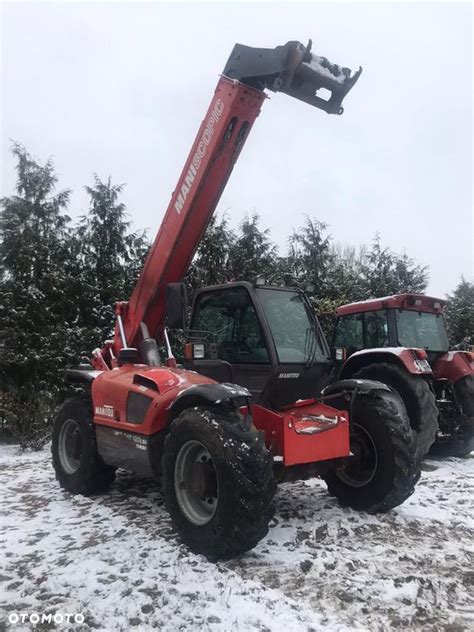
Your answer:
252,401 -> 350,466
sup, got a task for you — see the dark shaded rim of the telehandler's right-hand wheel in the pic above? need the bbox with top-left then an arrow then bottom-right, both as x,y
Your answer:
336,424 -> 378,487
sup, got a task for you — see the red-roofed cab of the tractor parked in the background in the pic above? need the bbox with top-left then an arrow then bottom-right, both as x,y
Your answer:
332,294 -> 449,364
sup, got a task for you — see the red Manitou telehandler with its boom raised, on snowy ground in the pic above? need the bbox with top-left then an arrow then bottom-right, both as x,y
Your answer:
52,42 -> 419,559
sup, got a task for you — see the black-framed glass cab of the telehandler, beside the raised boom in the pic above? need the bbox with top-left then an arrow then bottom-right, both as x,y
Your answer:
168,282 -> 331,409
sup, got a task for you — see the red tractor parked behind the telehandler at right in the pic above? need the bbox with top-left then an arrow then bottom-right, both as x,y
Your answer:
333,293 -> 474,456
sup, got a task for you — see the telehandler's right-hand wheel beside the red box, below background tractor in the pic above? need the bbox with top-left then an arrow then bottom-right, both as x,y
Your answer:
323,391 -> 420,513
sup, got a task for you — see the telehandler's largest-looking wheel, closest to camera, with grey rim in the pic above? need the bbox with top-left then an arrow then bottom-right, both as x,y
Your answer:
162,407 -> 276,561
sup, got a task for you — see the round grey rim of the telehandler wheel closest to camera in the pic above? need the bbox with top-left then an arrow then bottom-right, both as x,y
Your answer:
174,441 -> 219,526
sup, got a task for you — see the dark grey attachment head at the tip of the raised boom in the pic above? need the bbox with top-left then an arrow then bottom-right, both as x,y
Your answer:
223,40 -> 362,114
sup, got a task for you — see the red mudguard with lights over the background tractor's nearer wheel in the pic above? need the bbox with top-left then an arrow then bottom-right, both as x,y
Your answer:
339,347 -> 432,380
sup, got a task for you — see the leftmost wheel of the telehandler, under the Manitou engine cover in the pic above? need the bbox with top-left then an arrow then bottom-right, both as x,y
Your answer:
51,396 -> 115,495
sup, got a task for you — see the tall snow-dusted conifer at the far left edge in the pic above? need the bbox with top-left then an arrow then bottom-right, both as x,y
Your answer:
0,143 -> 71,443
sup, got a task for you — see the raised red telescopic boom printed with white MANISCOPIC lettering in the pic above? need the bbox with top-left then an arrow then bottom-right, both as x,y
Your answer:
107,77 -> 266,356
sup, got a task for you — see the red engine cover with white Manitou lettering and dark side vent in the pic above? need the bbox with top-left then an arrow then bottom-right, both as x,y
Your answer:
92,364 -> 214,435
